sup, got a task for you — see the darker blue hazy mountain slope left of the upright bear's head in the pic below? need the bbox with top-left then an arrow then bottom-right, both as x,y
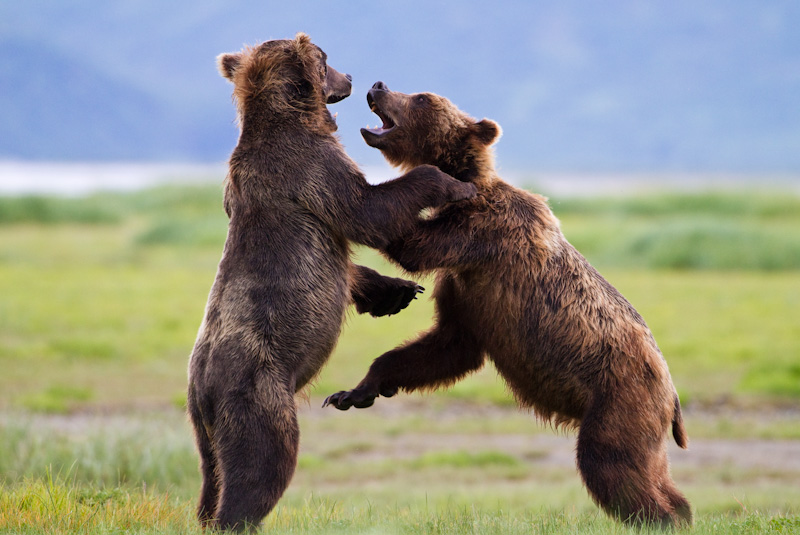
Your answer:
0,41 -> 180,160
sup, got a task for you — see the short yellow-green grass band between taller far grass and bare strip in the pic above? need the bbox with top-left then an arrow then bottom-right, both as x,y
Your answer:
0,260 -> 788,409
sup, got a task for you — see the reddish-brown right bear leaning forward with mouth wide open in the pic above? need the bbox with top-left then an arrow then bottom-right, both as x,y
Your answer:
326,82 -> 692,526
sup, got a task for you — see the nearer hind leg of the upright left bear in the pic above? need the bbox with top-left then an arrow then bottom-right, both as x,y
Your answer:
214,381 -> 300,531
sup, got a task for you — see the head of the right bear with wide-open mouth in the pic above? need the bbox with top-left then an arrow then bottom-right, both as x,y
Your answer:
361,82 -> 500,182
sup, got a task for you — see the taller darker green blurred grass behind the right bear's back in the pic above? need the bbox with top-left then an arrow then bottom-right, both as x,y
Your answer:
551,192 -> 800,271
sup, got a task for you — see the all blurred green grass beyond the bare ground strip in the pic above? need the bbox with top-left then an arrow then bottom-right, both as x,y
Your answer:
0,187 -> 800,412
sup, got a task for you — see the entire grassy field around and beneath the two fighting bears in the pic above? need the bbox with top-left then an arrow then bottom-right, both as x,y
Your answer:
0,187 -> 800,533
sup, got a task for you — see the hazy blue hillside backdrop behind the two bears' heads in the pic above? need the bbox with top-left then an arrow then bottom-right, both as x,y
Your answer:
0,0 -> 800,173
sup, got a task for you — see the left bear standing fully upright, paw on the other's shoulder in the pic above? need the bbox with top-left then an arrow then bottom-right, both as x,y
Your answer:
188,34 -> 475,530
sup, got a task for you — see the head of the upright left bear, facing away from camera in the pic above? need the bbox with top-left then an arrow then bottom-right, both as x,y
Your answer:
217,33 -> 352,133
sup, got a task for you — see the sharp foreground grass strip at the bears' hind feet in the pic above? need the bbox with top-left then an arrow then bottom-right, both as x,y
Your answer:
0,477 -> 800,535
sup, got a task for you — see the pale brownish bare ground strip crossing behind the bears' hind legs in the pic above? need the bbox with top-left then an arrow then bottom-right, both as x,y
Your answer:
6,397 -> 800,476
